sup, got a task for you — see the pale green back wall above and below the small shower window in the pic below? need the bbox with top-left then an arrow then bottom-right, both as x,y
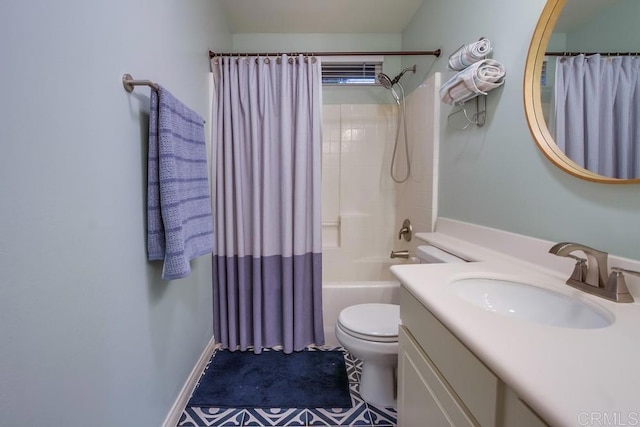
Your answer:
233,33 -> 401,104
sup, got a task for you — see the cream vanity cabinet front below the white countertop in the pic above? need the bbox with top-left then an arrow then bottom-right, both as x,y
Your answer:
398,287 -> 546,427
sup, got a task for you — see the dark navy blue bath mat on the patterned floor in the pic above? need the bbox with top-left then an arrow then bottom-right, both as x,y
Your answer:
188,350 -> 351,408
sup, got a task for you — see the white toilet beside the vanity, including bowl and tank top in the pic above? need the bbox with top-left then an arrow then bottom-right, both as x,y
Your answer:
335,245 -> 466,408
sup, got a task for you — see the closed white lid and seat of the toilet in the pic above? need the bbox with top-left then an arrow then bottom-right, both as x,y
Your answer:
338,304 -> 400,341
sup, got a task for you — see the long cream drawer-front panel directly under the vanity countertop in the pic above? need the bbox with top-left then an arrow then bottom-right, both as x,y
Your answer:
400,288 -> 501,426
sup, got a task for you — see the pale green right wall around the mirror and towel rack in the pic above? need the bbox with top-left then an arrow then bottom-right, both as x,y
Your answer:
402,0 -> 640,259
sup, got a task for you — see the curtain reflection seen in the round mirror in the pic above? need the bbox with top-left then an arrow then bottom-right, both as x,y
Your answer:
551,55 -> 640,178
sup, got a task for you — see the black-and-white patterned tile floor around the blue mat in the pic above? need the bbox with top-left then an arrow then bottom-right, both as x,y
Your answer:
178,348 -> 397,427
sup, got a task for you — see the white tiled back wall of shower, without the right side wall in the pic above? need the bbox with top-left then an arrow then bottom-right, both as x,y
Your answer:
322,104 -> 396,281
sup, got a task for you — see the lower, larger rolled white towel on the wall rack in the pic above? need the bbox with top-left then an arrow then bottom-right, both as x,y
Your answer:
440,59 -> 505,105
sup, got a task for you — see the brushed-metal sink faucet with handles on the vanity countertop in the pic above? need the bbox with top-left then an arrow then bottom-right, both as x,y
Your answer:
549,242 -> 633,302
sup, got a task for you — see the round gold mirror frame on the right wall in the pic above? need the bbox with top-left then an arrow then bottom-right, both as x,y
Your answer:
524,0 -> 640,184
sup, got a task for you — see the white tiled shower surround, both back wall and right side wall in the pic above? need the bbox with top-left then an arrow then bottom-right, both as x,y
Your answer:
322,74 -> 439,282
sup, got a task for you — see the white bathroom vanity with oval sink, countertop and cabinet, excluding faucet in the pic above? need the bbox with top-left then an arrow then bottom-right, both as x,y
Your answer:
391,219 -> 640,427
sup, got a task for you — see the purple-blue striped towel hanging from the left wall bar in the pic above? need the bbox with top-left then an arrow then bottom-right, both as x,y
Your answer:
147,87 -> 213,280
